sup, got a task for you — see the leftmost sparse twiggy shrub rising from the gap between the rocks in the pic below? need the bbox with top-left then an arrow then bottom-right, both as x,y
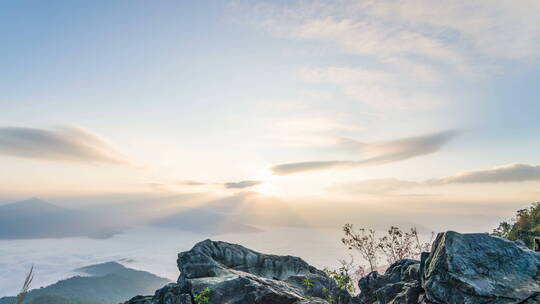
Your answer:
341,224 -> 380,271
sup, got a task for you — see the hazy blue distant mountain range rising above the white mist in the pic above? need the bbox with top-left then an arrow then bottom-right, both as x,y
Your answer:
0,198 -> 260,240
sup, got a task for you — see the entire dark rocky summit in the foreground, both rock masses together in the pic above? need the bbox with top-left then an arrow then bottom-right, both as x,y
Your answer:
126,231 -> 540,304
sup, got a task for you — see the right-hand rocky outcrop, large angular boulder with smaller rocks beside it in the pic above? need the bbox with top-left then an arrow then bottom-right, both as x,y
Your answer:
358,231 -> 540,304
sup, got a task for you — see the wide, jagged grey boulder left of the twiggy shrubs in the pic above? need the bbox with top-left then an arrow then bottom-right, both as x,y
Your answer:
128,240 -> 353,304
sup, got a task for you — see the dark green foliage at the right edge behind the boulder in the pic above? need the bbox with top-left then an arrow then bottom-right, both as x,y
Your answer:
492,202 -> 540,248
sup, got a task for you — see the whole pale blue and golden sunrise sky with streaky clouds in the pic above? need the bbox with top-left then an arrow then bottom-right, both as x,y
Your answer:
0,0 -> 540,230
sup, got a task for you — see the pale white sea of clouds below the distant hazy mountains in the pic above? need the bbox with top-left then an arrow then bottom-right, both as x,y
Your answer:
0,227 -> 348,297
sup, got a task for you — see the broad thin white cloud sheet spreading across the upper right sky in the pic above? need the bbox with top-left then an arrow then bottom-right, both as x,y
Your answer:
233,0 -> 540,110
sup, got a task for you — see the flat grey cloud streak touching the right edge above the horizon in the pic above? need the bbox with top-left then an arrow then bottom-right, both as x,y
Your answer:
427,164 -> 540,184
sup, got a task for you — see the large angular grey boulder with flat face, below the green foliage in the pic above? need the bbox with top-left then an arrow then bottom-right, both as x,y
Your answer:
422,231 -> 540,304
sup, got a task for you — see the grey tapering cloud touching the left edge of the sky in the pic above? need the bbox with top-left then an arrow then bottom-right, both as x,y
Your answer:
0,127 -> 129,165
